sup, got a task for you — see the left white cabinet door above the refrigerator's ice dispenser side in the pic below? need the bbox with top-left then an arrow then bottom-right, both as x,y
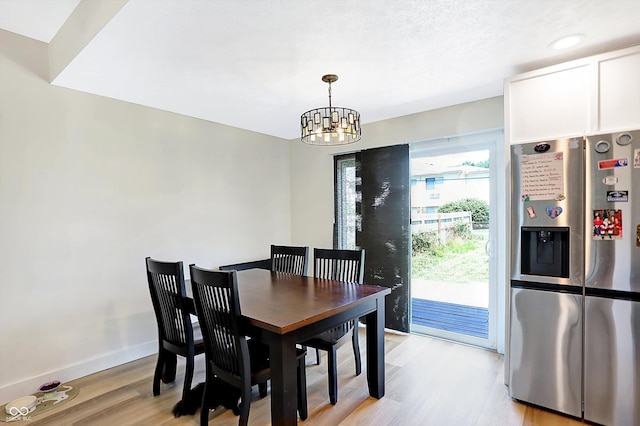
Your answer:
506,63 -> 591,143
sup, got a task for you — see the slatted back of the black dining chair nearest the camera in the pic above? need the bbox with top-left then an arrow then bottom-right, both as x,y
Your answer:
189,265 -> 250,381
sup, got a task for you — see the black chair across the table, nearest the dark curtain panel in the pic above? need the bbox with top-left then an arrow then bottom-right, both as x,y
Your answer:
302,249 -> 364,404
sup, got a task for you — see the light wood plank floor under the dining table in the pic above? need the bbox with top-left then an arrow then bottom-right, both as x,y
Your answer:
21,329 -> 581,426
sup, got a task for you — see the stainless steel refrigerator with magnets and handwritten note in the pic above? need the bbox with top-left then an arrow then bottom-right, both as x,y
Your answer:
508,131 -> 640,426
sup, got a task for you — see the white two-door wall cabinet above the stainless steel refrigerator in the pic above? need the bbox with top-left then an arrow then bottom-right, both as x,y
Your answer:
504,46 -> 640,144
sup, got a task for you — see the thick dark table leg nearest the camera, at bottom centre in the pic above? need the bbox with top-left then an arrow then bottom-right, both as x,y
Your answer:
269,334 -> 298,425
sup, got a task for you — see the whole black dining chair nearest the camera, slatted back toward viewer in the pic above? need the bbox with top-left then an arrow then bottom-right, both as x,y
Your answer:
189,265 -> 308,425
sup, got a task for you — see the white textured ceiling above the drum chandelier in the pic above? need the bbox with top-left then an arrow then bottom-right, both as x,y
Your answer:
0,0 -> 640,139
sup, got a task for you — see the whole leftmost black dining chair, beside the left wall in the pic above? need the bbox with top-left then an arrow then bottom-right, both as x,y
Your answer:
146,257 -> 204,401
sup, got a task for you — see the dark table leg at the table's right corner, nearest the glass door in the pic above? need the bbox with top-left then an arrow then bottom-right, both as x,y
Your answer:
366,298 -> 384,399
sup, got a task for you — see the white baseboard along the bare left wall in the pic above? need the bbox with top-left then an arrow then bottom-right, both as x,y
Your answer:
0,340 -> 158,404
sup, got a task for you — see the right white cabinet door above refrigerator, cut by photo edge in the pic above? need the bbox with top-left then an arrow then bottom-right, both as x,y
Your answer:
598,49 -> 640,132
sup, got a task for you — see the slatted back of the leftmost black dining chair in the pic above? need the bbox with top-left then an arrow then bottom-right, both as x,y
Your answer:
146,257 -> 193,346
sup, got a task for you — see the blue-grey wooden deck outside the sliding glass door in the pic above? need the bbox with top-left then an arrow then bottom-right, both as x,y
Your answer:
411,298 -> 489,339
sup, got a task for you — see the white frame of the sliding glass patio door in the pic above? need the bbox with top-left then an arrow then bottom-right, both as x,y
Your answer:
409,131 -> 504,349
